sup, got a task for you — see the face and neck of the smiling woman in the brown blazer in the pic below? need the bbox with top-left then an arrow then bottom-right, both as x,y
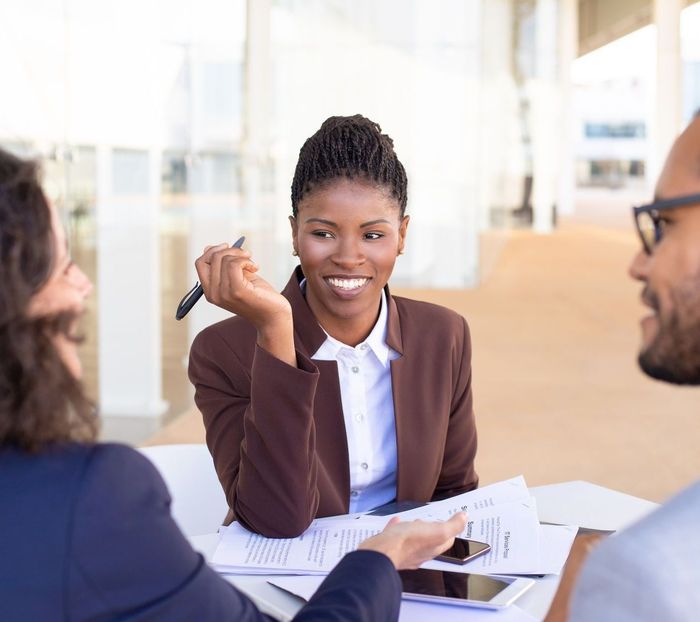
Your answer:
290,179 -> 409,346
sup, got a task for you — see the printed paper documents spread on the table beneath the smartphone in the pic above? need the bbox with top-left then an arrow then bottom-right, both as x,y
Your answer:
212,476 -> 576,575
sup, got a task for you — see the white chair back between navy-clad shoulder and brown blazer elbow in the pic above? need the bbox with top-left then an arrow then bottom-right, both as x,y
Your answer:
139,445 -> 228,537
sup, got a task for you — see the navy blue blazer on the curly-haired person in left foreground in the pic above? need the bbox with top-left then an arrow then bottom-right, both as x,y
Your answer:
0,444 -> 401,622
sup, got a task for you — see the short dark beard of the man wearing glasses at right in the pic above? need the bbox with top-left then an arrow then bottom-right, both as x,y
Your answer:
638,275 -> 700,384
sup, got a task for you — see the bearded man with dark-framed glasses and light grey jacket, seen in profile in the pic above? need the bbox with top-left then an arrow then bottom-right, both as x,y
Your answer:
546,116 -> 700,622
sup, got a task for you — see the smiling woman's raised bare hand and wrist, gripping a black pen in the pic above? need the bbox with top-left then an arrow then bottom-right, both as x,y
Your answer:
194,244 -> 296,366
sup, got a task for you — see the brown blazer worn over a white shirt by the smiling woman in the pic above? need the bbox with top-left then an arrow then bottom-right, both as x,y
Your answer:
189,268 -> 478,537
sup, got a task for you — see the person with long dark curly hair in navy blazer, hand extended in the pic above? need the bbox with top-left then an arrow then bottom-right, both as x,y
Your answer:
0,150 -> 465,622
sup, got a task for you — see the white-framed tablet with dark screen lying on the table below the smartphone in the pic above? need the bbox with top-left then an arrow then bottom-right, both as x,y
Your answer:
399,568 -> 535,609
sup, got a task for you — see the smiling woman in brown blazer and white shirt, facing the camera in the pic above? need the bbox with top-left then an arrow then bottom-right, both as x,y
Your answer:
189,115 -> 477,537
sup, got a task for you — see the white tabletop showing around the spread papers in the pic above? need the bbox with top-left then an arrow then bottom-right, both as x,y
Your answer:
190,481 -> 657,621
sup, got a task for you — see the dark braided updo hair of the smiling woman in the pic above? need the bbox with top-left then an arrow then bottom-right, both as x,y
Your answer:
292,114 -> 408,218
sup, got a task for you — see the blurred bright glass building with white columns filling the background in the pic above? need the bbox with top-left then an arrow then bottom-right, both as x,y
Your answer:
0,0 -> 700,494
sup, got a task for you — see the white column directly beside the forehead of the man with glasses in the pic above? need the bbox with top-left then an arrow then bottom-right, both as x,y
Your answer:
647,0 -> 685,186
